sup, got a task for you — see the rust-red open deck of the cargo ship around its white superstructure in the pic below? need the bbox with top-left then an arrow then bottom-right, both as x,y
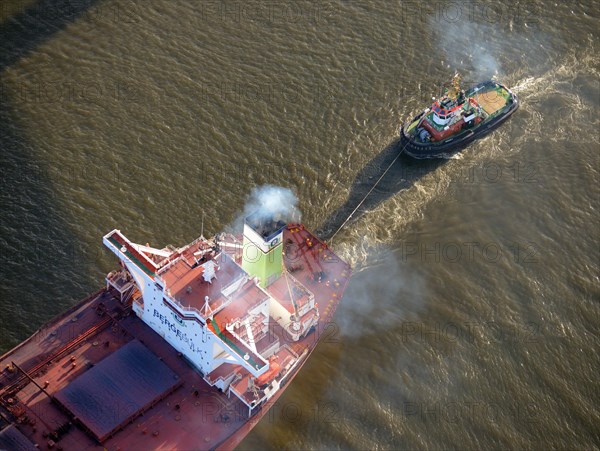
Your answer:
0,225 -> 351,450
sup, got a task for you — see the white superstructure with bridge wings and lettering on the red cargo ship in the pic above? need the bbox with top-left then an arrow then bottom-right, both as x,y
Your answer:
103,217 -> 319,411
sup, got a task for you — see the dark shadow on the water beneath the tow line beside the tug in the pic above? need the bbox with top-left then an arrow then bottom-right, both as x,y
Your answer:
317,139 -> 448,241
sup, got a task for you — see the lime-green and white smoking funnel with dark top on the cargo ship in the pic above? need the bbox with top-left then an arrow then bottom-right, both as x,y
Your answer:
242,212 -> 287,288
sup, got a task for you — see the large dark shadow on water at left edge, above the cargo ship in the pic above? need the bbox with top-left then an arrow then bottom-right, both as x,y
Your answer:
0,96 -> 89,354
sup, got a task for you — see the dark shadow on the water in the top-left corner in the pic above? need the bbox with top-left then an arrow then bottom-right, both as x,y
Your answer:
0,0 -> 98,72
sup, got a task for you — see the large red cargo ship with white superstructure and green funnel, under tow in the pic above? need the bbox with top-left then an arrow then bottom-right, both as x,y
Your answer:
0,213 -> 351,450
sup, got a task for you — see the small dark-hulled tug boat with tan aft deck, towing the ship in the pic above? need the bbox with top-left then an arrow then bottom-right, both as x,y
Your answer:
400,74 -> 519,158
